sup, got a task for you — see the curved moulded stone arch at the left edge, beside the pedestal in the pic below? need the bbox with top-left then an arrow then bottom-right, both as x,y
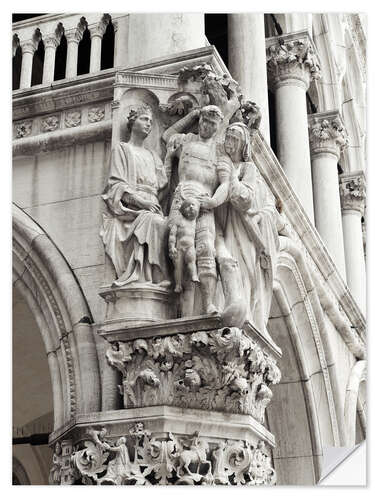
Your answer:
13,204 -> 100,430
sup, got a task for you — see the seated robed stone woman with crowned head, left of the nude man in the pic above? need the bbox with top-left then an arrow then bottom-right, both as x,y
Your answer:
100,105 -> 169,286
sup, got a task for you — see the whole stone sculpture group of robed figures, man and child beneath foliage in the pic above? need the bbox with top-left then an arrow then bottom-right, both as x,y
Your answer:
101,65 -> 283,334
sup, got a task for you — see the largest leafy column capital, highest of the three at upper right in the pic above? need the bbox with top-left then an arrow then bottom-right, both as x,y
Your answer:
266,30 -> 320,90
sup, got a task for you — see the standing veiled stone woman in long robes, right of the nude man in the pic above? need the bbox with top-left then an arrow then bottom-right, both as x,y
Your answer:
219,122 -> 279,333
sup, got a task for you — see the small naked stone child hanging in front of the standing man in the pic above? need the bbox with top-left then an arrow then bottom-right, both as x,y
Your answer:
169,198 -> 200,293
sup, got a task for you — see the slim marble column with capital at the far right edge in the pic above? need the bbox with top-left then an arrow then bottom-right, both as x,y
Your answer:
340,171 -> 366,314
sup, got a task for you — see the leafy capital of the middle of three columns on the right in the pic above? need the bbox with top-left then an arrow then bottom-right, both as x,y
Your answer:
308,110 -> 348,160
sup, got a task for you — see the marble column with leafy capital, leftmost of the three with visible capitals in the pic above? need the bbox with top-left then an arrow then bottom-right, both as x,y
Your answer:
266,30 -> 320,223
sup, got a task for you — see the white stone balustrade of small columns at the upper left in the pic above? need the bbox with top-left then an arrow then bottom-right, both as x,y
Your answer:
13,13 -> 122,89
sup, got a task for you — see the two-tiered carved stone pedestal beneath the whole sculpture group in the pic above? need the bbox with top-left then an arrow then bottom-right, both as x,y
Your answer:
50,317 -> 280,485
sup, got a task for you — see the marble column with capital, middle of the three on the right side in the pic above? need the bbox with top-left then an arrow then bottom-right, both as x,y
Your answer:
309,111 -> 348,279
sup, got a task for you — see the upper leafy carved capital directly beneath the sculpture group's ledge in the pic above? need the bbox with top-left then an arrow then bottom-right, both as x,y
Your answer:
107,328 -> 280,422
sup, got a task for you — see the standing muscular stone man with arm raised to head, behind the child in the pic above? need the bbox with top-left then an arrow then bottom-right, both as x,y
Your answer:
163,105 -> 232,315
